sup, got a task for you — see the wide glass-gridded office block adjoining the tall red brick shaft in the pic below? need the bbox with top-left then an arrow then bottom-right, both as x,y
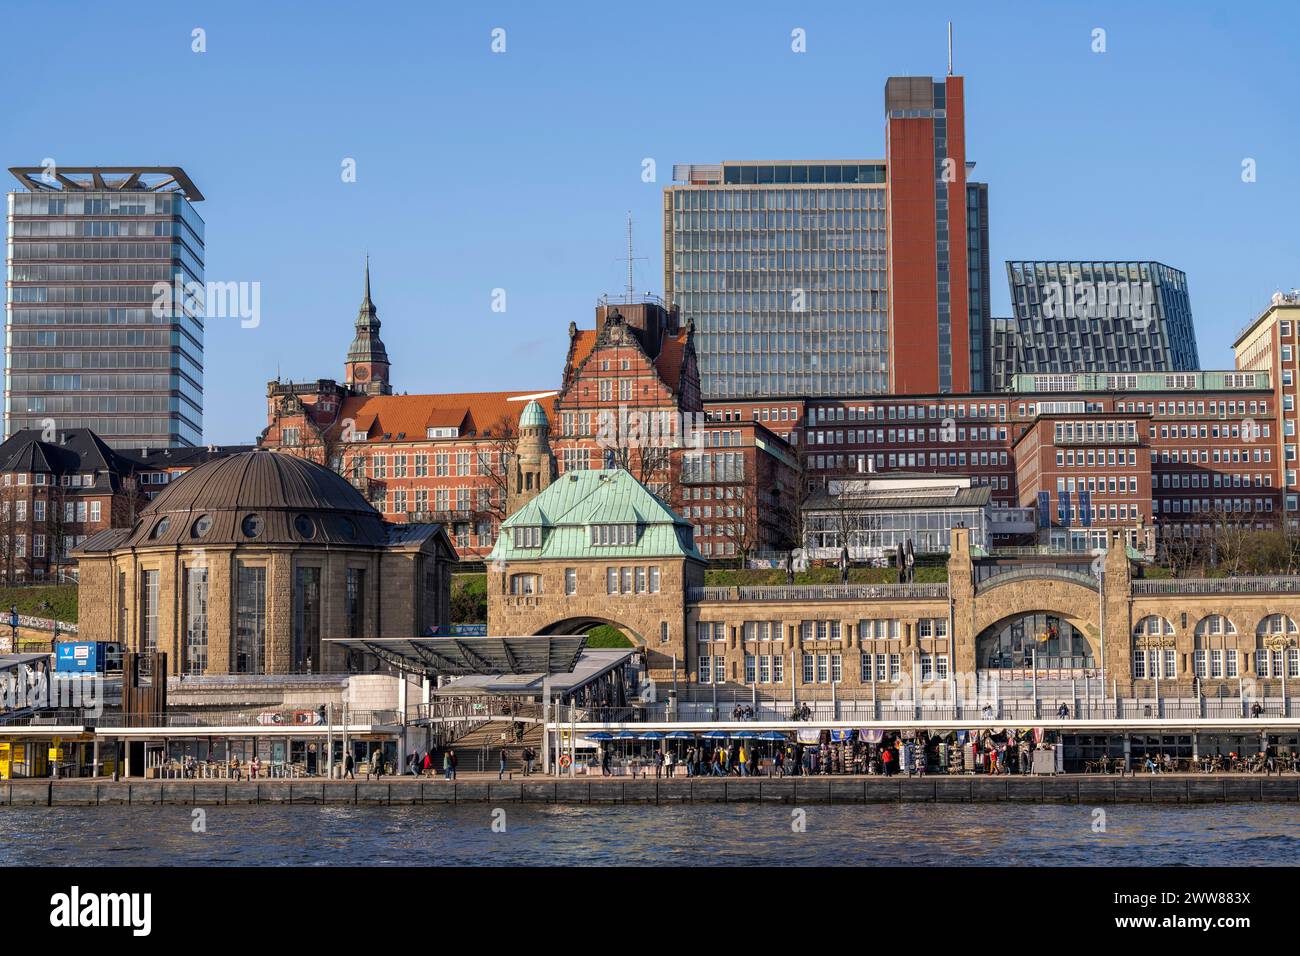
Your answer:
664,160 -> 889,398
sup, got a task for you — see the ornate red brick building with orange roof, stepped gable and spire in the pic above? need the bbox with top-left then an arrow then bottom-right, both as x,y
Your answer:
259,274 -> 794,559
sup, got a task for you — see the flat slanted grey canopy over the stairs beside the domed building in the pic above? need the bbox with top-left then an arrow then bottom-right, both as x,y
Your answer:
321,635 -> 586,678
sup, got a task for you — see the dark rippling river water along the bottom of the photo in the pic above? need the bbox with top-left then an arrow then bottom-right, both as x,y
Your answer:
0,804 -> 1300,866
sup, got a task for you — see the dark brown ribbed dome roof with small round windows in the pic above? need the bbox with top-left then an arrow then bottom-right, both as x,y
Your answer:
122,450 -> 387,548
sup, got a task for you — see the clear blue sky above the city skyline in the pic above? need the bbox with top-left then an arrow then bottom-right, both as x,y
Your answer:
0,0 -> 1300,442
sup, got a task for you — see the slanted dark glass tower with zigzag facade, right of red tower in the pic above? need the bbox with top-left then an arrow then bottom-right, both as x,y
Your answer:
1004,260 -> 1200,380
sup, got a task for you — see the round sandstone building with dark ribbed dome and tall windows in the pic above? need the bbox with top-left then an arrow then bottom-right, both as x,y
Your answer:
73,450 -> 456,674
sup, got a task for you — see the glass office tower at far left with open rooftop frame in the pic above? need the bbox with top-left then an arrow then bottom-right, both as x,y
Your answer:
4,166 -> 204,449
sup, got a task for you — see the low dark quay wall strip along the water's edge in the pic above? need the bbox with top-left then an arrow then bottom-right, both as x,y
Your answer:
10,774 -> 1300,813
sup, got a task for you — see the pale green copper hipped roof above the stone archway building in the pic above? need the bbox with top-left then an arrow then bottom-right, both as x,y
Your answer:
488,468 -> 703,561
